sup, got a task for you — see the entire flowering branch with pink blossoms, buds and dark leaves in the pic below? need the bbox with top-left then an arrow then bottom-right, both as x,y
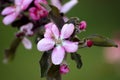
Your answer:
0,0 -> 116,80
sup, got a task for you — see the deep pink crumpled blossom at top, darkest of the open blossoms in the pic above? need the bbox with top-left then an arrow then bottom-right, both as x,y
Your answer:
29,0 -> 48,20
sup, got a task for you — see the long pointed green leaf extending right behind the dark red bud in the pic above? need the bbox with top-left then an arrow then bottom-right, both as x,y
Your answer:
86,35 -> 118,47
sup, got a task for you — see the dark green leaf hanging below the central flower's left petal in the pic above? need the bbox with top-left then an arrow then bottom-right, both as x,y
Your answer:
39,51 -> 52,77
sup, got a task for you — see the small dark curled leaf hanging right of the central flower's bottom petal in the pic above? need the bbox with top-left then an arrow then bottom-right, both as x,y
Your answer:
71,53 -> 82,69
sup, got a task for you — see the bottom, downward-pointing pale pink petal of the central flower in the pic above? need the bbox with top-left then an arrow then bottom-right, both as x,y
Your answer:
52,46 -> 65,65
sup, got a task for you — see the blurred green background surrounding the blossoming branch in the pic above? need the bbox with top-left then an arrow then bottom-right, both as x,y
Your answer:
0,0 -> 120,80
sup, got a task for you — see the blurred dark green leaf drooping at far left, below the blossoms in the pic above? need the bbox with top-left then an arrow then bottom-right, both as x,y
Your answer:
4,38 -> 22,63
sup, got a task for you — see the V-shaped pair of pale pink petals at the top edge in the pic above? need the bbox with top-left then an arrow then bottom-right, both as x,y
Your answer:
51,0 -> 78,13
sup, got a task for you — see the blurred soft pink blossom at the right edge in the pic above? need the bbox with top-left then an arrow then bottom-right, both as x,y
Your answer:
104,39 -> 120,64
